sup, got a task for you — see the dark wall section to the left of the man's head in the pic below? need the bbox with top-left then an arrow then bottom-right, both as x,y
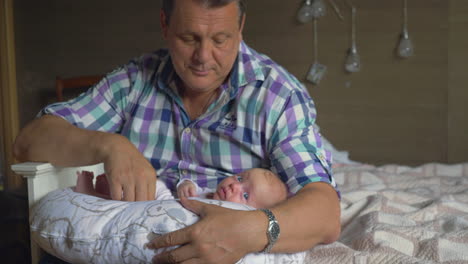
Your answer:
15,0 -> 163,122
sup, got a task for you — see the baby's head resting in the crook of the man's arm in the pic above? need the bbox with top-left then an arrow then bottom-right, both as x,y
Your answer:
213,169 -> 288,208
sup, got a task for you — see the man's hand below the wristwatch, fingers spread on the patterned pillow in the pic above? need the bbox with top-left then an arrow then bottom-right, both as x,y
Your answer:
148,197 -> 268,263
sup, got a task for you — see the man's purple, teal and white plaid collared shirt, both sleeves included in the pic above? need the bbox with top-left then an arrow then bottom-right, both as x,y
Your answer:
40,42 -> 336,193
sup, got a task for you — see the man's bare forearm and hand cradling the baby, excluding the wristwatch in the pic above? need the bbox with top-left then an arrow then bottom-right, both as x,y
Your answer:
148,182 -> 340,263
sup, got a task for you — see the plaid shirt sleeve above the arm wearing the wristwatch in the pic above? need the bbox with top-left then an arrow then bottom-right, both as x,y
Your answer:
269,90 -> 339,195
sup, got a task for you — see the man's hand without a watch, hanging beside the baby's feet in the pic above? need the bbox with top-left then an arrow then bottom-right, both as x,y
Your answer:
103,134 -> 156,201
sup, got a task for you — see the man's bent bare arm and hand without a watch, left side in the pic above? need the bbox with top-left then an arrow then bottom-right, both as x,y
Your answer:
14,115 -> 156,201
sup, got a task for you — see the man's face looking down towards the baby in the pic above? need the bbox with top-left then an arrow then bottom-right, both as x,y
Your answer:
161,0 -> 243,92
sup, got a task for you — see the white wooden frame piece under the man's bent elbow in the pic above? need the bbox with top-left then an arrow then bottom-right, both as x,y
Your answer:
11,162 -> 104,264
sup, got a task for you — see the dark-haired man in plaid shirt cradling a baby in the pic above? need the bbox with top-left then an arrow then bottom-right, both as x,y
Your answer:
15,0 -> 340,263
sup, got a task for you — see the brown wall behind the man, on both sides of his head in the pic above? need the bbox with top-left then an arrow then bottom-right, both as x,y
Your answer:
15,0 -> 468,165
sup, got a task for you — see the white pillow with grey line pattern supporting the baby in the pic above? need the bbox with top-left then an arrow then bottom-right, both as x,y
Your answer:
30,188 -> 306,264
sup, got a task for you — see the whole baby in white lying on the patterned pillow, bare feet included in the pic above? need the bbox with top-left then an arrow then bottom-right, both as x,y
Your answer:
75,168 -> 288,208
